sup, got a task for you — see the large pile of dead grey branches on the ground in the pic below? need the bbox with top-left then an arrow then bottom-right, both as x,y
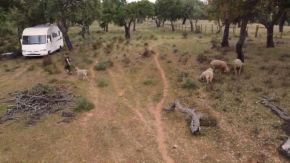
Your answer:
0,84 -> 75,124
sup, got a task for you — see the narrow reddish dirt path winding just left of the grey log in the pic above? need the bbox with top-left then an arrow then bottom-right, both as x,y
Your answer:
152,53 -> 174,163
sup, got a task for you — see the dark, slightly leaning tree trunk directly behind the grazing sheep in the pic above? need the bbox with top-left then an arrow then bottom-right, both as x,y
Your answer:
236,18 -> 249,63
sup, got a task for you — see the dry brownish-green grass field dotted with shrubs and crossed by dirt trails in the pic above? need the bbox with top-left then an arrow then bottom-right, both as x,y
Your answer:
0,21 -> 290,163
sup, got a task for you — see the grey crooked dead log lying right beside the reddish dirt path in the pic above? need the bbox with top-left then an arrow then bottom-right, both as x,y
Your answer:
164,100 -> 200,133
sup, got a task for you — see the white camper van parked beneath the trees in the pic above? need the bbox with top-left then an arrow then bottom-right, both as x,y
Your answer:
21,25 -> 63,57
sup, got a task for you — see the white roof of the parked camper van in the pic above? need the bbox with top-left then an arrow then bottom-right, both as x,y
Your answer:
22,25 -> 55,36
